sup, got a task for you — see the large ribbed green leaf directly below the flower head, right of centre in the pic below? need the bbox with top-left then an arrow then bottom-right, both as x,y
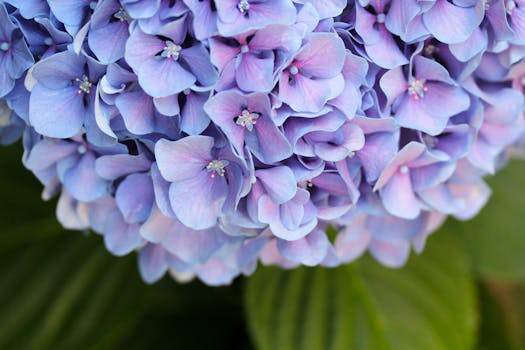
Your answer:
245,234 -> 477,350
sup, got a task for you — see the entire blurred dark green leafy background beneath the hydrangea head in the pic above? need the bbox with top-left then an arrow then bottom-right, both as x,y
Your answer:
0,145 -> 525,350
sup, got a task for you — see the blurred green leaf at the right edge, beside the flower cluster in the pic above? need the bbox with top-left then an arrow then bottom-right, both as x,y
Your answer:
448,160 -> 525,281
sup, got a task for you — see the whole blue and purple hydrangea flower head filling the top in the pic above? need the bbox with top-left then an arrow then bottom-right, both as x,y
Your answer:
0,0 -> 525,285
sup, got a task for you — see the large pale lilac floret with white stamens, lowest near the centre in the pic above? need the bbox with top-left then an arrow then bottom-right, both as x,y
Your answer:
155,135 -> 246,230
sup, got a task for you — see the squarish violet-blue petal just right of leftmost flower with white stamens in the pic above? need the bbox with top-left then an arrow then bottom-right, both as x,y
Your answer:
115,90 -> 155,135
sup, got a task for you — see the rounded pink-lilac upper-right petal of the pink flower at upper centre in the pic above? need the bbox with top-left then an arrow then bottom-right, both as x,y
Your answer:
295,33 -> 346,78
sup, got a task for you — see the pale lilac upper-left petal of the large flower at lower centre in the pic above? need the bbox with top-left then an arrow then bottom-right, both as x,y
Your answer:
155,135 -> 214,182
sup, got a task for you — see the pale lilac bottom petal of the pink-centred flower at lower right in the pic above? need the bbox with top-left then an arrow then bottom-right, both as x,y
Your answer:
379,171 -> 421,219
